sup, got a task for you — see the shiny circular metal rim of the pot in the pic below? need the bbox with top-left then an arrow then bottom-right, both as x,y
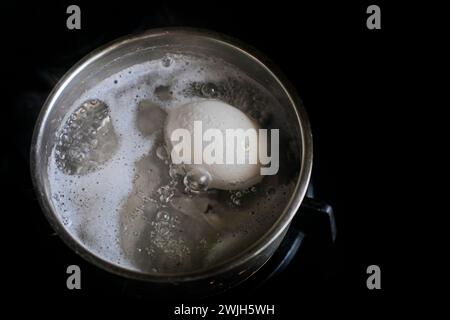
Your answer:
30,27 -> 313,283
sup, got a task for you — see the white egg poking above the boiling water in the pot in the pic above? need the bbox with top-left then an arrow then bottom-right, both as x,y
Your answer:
164,100 -> 263,190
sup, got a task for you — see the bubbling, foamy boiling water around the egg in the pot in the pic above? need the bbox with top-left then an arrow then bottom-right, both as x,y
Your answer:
49,54 -> 298,273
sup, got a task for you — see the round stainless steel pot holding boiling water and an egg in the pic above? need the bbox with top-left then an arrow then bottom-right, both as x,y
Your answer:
31,29 -> 312,291
